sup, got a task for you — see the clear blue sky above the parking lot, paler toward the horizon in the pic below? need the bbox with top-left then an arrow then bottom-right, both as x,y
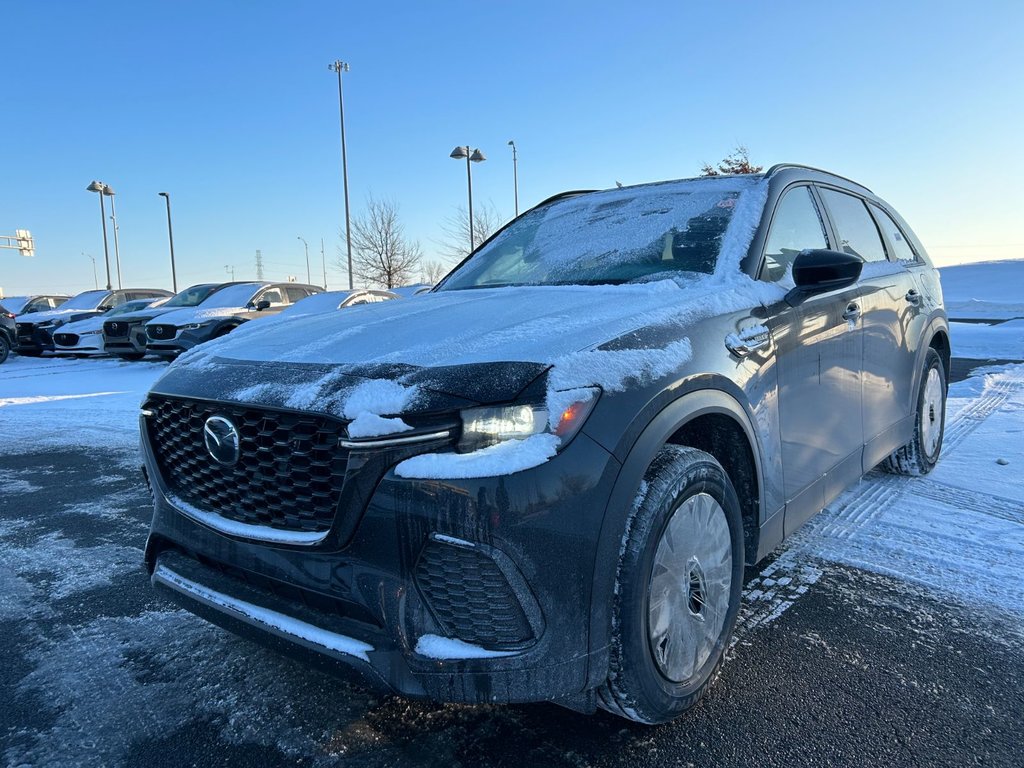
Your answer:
0,0 -> 1024,295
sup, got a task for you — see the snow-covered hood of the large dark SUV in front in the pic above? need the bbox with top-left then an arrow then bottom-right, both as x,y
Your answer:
157,274 -> 778,410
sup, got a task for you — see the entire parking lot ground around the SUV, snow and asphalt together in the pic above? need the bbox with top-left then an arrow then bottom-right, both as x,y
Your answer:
0,357 -> 1024,766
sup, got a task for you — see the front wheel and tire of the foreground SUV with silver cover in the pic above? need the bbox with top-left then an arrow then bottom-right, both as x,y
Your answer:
598,445 -> 743,724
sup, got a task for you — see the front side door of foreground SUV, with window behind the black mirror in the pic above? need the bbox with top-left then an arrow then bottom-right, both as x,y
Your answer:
760,184 -> 863,536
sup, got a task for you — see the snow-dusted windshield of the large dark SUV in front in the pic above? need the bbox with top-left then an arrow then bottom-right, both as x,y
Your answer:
438,179 -> 745,291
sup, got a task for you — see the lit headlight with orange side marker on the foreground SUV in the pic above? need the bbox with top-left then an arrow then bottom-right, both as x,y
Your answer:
458,388 -> 601,454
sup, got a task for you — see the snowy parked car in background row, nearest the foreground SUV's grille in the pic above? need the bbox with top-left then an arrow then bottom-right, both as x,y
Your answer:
145,283 -> 324,358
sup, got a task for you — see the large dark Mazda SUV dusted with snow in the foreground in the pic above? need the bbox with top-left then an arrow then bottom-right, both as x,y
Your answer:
141,166 -> 950,723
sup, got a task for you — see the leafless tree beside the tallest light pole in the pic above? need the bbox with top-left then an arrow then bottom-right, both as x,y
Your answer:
338,197 -> 422,288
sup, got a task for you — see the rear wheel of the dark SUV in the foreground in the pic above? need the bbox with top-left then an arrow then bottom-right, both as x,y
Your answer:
880,349 -> 946,476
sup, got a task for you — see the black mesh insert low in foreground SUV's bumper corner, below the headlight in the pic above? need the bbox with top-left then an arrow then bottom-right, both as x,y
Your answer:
416,541 -> 534,648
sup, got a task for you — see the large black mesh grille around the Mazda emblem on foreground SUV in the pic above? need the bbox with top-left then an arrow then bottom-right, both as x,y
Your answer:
146,397 -> 348,532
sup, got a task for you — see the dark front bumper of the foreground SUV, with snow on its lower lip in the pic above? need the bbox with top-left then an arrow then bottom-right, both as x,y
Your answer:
142,409 -> 618,706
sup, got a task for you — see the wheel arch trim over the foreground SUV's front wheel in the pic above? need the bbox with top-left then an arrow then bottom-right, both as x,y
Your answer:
590,385 -> 764,685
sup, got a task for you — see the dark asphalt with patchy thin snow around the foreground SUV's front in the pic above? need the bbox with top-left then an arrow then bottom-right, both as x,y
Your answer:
0,376 -> 1024,768
